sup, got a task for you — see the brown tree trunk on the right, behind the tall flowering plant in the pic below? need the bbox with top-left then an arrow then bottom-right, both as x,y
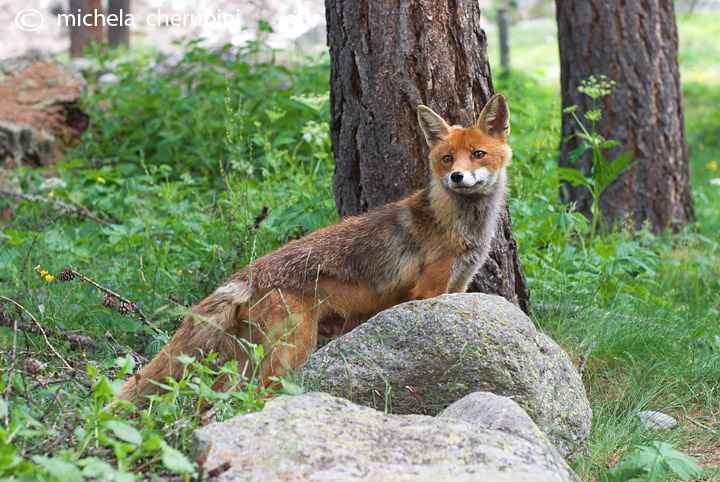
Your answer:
557,0 -> 695,232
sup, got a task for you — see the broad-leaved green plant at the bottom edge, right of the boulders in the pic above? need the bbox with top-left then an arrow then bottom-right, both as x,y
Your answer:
602,441 -> 704,482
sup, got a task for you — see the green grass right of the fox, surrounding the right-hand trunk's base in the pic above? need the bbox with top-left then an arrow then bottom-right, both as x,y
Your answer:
489,14 -> 720,480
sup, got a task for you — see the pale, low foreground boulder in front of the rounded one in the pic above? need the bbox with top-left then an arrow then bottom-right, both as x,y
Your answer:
194,393 -> 577,482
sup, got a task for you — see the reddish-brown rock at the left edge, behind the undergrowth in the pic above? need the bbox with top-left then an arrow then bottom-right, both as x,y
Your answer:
0,57 -> 89,169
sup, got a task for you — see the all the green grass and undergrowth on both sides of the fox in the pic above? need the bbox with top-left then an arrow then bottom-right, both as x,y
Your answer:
0,14 -> 720,480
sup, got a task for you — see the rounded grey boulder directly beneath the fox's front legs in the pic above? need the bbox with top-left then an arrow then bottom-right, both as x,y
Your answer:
300,293 -> 592,459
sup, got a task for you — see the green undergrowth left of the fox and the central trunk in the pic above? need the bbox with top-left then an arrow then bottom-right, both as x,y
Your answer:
0,33 -> 336,480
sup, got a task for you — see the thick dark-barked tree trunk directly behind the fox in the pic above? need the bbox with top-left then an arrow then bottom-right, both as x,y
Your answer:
325,0 -> 529,312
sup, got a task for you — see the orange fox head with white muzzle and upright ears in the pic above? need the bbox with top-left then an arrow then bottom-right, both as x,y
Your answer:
418,94 -> 512,194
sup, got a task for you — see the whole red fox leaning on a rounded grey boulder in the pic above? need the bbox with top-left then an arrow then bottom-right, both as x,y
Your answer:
118,94 -> 512,402
